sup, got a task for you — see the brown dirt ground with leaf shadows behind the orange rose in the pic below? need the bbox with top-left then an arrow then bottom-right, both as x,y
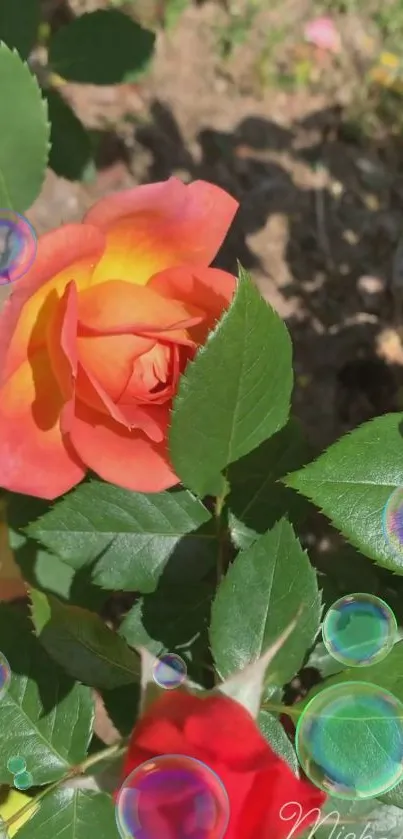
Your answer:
22,0 -> 403,449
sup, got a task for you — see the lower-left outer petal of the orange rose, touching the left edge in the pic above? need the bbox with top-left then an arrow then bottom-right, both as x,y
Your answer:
0,350 -> 86,499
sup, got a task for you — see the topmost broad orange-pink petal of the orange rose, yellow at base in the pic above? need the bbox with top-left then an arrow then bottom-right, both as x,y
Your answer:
85,178 -> 238,285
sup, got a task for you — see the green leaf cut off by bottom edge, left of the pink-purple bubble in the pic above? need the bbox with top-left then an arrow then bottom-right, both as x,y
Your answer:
18,787 -> 120,839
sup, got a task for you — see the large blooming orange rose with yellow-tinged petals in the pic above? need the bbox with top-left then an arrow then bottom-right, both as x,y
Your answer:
0,178 -> 238,499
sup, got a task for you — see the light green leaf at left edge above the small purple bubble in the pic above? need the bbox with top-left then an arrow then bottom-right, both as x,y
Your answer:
0,44 -> 49,213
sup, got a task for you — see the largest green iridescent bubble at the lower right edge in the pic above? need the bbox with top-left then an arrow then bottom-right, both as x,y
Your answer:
296,682 -> 403,801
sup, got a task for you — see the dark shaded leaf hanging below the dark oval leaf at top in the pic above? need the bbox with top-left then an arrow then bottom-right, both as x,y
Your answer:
46,90 -> 95,181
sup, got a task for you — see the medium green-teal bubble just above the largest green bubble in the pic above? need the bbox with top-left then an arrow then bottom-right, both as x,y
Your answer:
322,593 -> 397,667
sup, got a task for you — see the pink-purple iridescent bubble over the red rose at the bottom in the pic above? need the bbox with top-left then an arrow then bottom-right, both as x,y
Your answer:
116,755 -> 229,839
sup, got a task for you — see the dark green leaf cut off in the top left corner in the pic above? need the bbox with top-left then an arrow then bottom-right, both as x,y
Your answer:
0,0 -> 41,58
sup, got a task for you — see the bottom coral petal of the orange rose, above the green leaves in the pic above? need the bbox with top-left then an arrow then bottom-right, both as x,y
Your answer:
70,402 -> 178,492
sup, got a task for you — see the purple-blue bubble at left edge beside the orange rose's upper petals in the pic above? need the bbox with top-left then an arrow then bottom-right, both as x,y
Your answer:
0,210 -> 37,285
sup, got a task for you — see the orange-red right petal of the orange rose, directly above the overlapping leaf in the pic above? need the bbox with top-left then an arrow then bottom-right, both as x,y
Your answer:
147,266 -> 237,344
